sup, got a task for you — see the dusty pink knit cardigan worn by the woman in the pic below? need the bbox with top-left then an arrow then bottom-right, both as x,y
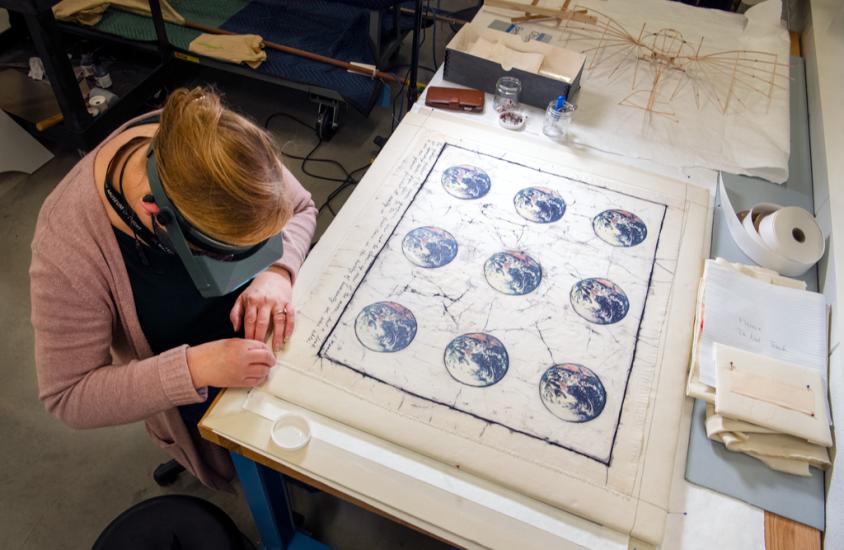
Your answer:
29,115 -> 317,489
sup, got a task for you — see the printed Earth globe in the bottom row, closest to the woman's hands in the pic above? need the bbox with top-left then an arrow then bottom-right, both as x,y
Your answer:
355,302 -> 416,352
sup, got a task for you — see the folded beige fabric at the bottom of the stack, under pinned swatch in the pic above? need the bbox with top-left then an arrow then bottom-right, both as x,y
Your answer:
706,404 -> 830,476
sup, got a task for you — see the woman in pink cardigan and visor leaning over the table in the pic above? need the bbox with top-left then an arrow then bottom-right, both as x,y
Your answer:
30,88 -> 316,488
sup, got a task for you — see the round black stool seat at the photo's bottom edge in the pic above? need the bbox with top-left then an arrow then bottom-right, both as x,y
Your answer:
93,495 -> 255,550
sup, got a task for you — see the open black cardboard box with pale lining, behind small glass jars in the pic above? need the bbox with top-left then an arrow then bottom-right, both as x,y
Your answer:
443,24 -> 586,109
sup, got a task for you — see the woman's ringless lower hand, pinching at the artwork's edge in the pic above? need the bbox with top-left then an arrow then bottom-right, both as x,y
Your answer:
187,338 -> 275,389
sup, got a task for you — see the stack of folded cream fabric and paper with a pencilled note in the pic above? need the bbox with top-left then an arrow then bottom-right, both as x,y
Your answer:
687,259 -> 832,476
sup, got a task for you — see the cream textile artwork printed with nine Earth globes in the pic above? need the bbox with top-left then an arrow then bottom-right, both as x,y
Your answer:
268,115 -> 710,542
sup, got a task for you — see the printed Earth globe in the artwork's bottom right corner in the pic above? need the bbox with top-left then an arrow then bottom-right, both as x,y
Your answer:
539,363 -> 607,423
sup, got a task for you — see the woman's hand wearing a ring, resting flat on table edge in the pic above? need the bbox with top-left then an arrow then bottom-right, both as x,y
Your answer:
229,266 -> 294,351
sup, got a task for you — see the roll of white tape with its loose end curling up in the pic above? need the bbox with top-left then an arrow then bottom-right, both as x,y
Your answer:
718,181 -> 825,277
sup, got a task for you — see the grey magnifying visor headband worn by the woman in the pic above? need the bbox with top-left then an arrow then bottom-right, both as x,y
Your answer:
147,146 -> 284,298
